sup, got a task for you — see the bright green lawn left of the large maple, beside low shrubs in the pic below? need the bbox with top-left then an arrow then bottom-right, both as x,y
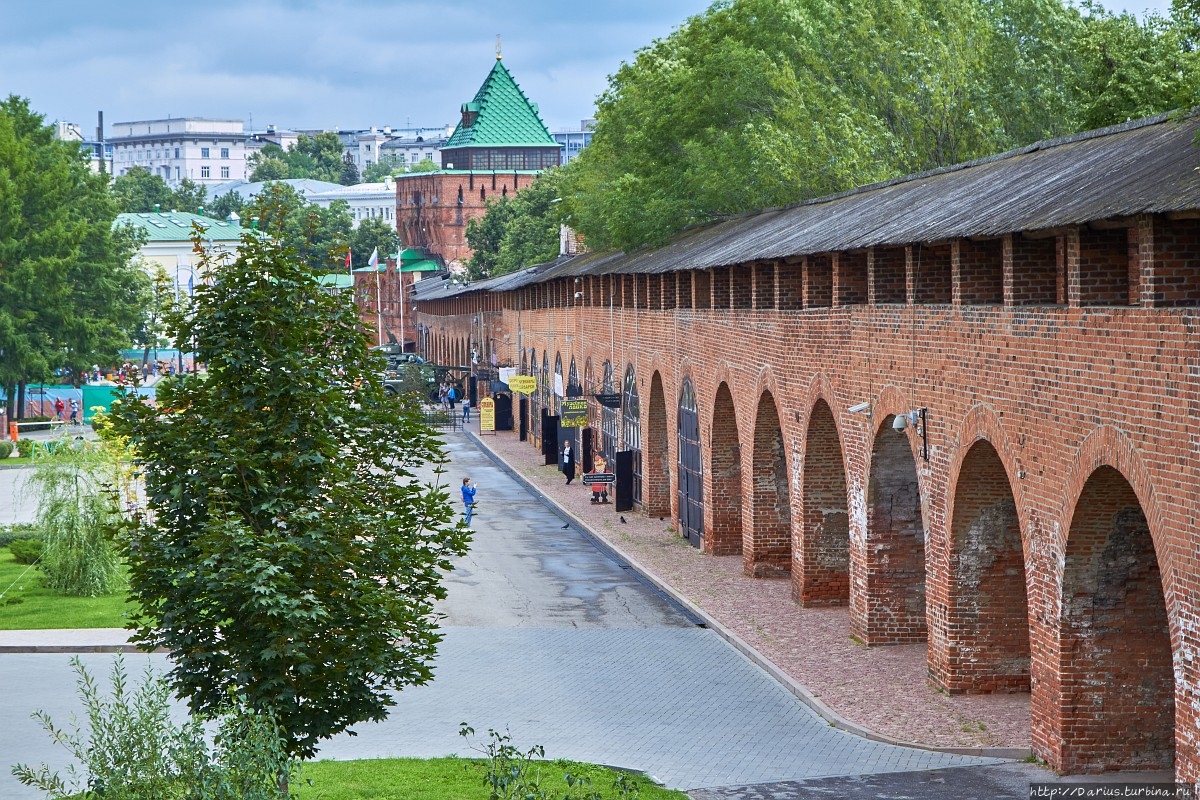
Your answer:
0,547 -> 132,631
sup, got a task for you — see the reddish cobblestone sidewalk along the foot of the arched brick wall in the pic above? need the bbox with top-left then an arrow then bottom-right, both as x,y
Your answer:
468,422 -> 1030,748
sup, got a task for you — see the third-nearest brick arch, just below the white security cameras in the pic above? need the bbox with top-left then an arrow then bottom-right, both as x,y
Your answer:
850,386 -> 928,645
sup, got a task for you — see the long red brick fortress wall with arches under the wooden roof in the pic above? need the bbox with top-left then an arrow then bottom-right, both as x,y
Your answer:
420,217 -> 1200,781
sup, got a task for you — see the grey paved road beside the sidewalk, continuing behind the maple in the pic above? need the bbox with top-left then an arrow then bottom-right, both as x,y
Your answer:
0,434 -> 996,799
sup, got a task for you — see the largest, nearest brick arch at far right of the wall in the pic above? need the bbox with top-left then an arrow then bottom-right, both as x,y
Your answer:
1034,427 -> 1176,772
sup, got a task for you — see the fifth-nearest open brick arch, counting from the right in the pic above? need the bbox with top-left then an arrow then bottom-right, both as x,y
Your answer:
742,391 -> 792,578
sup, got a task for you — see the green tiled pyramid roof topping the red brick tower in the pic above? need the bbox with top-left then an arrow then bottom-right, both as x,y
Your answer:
442,59 -> 560,170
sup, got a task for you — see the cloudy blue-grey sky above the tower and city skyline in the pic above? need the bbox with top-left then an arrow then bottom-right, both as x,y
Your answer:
0,0 -> 1170,132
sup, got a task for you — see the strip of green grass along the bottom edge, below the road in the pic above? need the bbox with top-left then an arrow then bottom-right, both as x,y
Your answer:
293,758 -> 688,800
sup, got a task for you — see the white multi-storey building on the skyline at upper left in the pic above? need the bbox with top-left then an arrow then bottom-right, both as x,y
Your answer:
108,116 -> 250,186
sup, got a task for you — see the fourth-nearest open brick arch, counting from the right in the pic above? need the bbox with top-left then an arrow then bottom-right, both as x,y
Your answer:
792,396 -> 850,607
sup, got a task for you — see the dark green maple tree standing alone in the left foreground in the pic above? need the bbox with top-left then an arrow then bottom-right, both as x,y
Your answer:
113,211 -> 469,757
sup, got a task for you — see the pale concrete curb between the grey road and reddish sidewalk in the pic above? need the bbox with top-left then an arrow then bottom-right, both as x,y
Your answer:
463,431 -> 1032,760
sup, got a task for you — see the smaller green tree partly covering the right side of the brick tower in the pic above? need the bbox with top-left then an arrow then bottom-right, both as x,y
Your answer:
467,169 -> 562,278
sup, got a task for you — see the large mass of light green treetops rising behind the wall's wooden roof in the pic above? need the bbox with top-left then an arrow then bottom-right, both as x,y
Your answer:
562,0 -> 1193,249
